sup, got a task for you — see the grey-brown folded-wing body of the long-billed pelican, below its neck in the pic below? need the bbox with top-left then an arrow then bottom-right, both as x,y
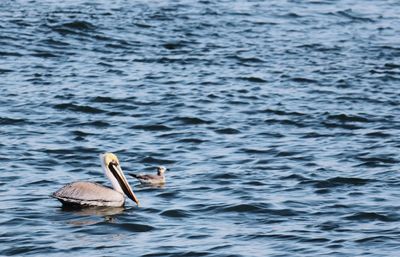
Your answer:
53,182 -> 125,206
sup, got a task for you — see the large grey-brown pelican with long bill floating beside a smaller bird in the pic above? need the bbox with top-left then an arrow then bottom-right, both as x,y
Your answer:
52,153 -> 139,207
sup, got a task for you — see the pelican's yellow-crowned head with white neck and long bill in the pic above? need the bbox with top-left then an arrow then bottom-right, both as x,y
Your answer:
100,153 -> 139,205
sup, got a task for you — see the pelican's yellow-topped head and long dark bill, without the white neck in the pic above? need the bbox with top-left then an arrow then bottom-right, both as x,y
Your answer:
103,153 -> 139,205
